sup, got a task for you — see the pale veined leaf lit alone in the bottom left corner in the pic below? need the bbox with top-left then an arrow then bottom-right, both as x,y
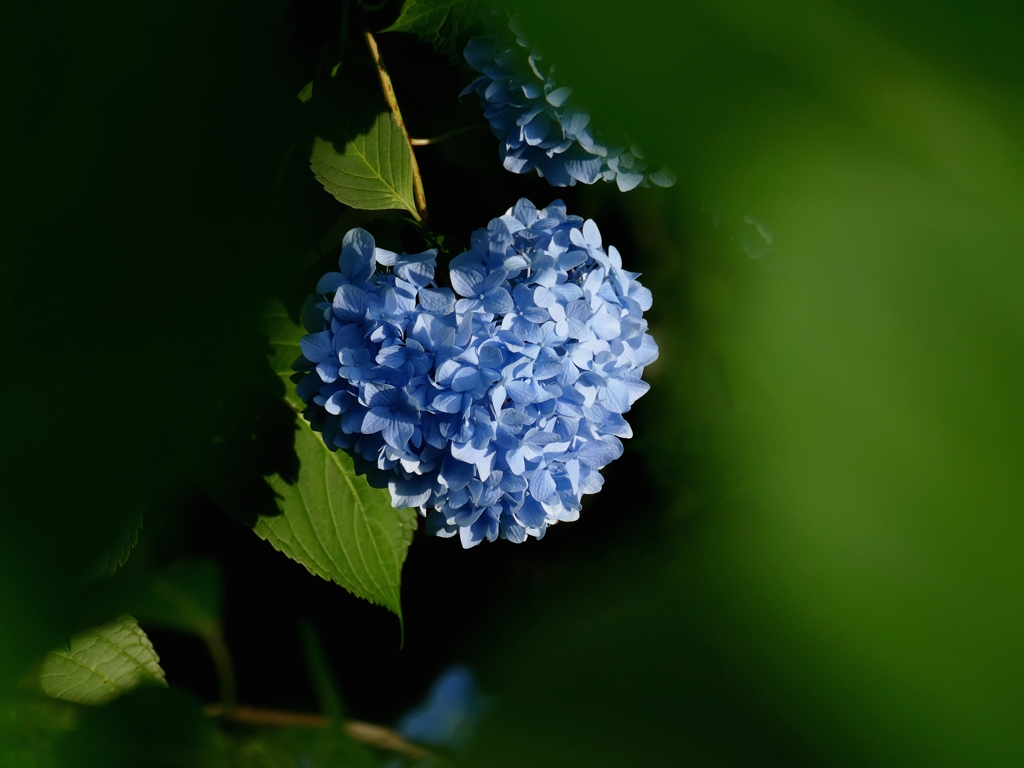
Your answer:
39,615 -> 166,705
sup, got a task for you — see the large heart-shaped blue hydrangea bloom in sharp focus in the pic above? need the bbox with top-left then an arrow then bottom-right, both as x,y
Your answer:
297,199 -> 657,547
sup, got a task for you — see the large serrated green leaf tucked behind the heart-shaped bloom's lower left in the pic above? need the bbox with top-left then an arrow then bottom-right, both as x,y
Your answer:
253,305 -> 416,621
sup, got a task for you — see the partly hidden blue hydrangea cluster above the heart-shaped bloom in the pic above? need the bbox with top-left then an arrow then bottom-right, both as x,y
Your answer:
462,19 -> 675,191
